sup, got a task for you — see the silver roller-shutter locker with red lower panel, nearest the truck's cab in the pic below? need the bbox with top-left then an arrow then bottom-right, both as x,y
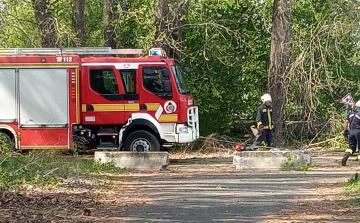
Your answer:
19,68 -> 71,149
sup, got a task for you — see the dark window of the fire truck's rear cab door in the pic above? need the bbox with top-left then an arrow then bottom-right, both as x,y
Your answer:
90,69 -> 119,95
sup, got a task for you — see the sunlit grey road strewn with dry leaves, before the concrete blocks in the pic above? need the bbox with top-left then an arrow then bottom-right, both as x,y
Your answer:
109,154 -> 360,222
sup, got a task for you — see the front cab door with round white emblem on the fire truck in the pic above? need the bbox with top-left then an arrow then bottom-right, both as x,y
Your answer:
138,64 -> 179,123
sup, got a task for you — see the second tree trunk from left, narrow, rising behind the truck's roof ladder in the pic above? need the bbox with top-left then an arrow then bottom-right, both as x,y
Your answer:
72,0 -> 85,47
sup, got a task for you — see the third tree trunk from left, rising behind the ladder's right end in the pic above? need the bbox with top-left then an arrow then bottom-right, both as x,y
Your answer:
104,0 -> 117,49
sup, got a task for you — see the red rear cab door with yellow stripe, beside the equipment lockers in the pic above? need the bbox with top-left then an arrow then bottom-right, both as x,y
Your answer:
81,66 -> 125,125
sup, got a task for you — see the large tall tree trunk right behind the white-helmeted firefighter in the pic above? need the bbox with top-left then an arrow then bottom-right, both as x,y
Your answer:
268,0 -> 293,145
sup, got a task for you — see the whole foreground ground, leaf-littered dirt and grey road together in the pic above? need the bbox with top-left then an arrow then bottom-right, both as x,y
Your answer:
0,153 -> 360,223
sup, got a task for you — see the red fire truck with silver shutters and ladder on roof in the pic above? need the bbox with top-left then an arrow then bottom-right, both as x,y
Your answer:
0,47 -> 199,152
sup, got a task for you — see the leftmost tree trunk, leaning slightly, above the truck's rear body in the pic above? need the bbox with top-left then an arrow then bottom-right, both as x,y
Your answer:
32,0 -> 60,47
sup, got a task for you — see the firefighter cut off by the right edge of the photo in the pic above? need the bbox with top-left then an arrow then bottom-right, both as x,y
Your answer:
341,100 -> 360,166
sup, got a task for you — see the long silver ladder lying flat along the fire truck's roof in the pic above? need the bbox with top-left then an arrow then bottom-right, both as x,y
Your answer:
0,47 -> 143,55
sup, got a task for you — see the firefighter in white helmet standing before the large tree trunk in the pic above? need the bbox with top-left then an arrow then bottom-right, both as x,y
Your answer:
255,94 -> 275,147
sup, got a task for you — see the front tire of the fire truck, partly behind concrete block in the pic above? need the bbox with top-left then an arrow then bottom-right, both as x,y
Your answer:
124,130 -> 161,152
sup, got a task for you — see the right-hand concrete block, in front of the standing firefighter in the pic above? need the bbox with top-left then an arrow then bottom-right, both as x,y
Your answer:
233,150 -> 311,170
